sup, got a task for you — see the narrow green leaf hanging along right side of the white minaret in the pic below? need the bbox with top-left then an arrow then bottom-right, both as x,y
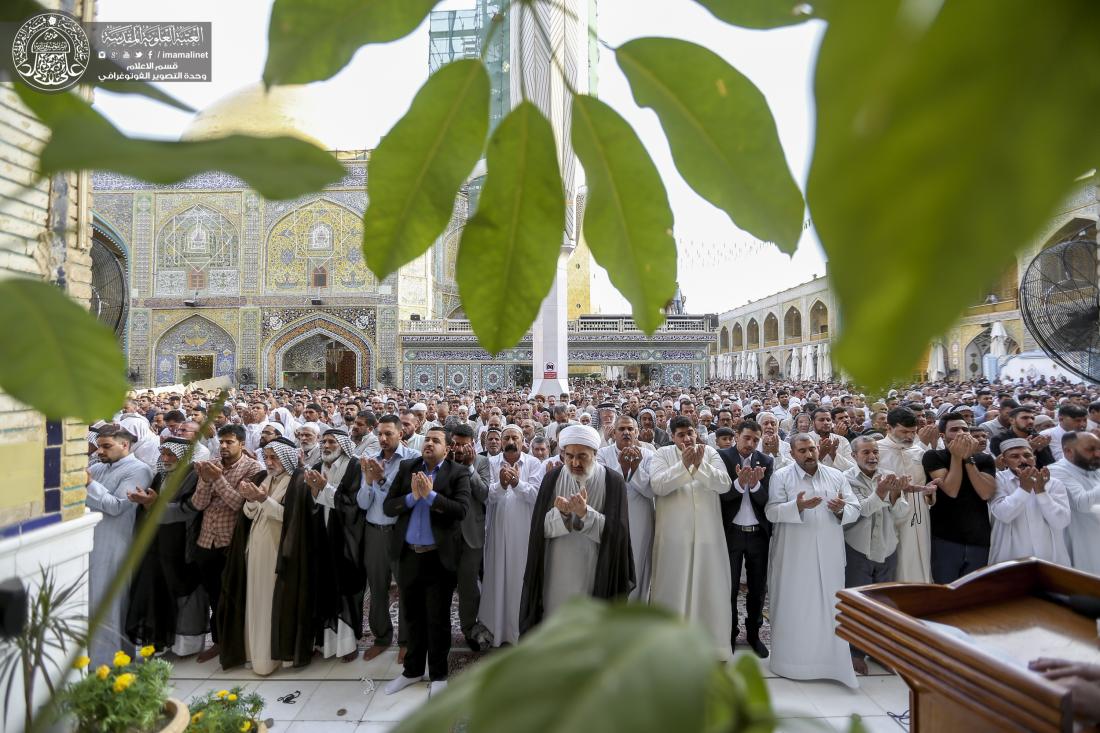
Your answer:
572,95 -> 677,333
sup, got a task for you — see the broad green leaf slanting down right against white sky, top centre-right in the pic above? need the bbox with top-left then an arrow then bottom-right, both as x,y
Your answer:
615,39 -> 805,254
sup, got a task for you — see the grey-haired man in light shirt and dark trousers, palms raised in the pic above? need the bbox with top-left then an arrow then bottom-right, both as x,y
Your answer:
844,435 -> 915,675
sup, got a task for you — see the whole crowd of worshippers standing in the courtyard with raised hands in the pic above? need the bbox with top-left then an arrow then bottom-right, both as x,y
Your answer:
87,382 -> 1100,692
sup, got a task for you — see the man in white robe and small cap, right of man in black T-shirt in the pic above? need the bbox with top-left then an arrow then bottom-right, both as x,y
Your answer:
989,437 -> 1069,566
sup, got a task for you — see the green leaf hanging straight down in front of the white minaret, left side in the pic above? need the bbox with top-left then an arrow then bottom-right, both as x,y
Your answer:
457,101 -> 565,353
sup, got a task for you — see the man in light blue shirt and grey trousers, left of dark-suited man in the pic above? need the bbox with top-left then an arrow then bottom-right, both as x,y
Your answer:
355,415 -> 420,661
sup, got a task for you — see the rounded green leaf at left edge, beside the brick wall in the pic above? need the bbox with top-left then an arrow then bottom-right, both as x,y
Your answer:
0,277 -> 129,423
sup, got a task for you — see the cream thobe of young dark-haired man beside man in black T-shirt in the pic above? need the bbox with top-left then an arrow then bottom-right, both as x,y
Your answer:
879,436 -> 935,583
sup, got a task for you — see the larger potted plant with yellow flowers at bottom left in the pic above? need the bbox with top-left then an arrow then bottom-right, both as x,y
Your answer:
59,646 -> 190,733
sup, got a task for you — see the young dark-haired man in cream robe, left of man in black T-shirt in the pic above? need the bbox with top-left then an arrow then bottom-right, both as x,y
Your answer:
871,407 -> 936,583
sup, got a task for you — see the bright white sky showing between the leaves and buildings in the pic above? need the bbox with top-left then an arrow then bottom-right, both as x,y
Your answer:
96,0 -> 825,314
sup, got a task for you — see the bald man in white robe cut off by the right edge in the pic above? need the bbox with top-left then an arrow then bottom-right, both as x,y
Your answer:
1049,433 -> 1100,576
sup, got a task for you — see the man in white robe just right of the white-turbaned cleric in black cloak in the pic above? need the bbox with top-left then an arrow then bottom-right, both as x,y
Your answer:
594,415 -> 655,602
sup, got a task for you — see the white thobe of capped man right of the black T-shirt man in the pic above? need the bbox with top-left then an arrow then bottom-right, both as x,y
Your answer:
989,470 -> 1069,566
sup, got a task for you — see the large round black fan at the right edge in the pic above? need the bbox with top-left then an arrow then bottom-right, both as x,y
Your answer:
1020,239 -> 1100,382
